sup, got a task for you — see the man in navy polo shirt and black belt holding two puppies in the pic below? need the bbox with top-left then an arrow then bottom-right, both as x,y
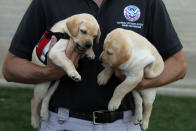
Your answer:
3,0 -> 186,131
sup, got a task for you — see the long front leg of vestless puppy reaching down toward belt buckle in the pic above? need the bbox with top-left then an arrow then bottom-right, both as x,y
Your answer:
108,70 -> 143,111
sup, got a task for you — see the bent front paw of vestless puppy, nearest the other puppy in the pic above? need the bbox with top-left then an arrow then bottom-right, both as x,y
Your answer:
97,67 -> 113,86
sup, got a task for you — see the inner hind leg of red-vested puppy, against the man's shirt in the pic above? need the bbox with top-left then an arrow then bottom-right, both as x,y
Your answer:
40,80 -> 60,121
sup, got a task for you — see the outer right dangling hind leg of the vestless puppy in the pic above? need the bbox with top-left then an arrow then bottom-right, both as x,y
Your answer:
140,88 -> 156,130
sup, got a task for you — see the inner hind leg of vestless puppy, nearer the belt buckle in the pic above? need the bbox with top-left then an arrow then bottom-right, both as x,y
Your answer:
132,90 -> 143,125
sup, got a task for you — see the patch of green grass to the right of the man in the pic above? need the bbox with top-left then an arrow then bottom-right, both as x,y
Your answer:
149,93 -> 196,131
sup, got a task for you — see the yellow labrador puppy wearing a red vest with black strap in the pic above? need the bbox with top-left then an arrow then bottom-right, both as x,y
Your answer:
31,13 -> 101,128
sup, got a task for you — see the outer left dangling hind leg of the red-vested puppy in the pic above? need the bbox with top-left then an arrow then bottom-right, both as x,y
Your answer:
31,82 -> 50,128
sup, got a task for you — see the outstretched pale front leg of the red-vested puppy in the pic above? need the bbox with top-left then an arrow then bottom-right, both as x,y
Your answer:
49,39 -> 81,81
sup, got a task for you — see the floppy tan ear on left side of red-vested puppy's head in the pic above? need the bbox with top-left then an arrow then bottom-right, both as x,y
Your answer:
66,17 -> 81,37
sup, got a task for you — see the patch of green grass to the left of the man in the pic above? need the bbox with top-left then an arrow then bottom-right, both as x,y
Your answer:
0,88 -> 34,131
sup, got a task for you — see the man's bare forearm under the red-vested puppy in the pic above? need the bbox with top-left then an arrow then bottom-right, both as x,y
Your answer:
2,53 -> 63,84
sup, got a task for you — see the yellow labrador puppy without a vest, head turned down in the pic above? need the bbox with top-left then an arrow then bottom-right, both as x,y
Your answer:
98,28 -> 164,130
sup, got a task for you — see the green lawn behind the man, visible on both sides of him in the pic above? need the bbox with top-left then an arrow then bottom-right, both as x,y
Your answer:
0,87 -> 196,131
